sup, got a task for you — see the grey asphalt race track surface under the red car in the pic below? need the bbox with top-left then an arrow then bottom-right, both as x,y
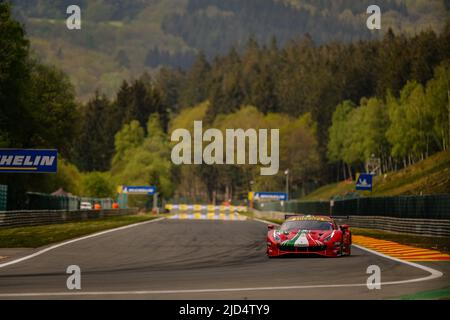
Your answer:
0,220 -> 450,299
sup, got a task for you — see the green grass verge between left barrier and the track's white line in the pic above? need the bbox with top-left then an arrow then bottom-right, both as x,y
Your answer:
0,215 -> 161,248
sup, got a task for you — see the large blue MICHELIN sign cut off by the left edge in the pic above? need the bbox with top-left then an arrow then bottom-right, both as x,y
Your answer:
0,149 -> 58,173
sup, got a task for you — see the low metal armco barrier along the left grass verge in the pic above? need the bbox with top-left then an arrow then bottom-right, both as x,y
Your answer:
0,209 -> 138,228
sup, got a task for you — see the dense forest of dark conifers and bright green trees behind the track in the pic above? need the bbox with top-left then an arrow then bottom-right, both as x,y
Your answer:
0,1 -> 450,206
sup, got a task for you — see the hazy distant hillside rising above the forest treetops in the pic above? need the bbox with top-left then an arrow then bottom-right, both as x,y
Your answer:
8,0 -> 450,102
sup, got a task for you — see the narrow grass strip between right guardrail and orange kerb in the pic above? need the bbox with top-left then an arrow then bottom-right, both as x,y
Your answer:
351,228 -> 450,253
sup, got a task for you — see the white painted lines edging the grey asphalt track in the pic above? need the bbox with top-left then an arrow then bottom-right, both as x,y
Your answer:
0,218 -> 443,298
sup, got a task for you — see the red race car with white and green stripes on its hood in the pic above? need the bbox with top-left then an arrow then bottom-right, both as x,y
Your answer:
267,215 -> 352,258
